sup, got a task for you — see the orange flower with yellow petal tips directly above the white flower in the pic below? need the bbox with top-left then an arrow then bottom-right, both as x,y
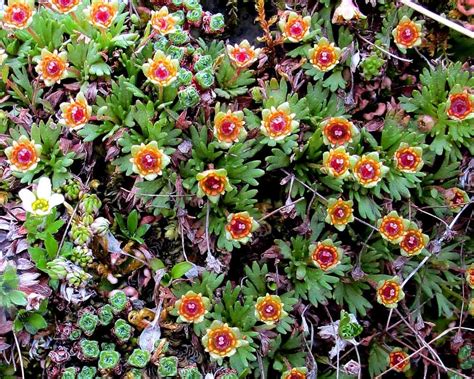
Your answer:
5,135 -> 42,172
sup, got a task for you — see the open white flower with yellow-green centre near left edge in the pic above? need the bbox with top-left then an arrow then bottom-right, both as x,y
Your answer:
18,176 -> 64,216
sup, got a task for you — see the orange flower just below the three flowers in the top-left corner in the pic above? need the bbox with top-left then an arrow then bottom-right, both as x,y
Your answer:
35,49 -> 69,86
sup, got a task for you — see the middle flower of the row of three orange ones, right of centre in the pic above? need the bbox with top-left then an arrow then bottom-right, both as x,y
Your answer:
349,152 -> 389,188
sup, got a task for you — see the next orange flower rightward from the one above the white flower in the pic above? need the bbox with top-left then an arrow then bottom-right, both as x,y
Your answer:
130,141 -> 171,180
